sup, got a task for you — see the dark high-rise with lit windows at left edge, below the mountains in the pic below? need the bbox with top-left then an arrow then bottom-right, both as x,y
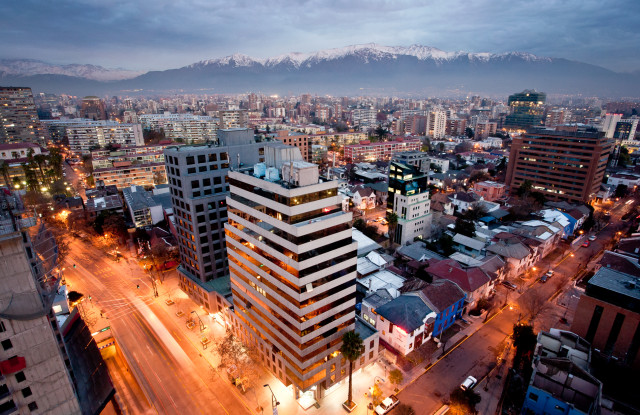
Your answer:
0,87 -> 45,146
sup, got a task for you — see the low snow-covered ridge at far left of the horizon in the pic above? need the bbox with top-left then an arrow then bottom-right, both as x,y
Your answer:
0,59 -> 144,81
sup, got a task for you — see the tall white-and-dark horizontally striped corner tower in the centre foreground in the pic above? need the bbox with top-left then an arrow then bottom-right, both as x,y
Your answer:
225,143 -> 378,399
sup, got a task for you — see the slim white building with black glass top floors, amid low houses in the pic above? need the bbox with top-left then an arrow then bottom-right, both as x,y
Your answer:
387,161 -> 432,245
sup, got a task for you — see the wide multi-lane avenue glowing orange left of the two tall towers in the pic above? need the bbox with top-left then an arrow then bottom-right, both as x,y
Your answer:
65,239 -> 252,415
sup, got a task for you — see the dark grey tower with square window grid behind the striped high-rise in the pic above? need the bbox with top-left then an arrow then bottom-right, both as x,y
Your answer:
164,128 -> 265,312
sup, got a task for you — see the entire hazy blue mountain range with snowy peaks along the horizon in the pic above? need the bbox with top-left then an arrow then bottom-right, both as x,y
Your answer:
0,44 -> 640,98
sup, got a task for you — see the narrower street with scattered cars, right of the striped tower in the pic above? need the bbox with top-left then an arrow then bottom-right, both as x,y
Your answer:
395,201 -> 633,415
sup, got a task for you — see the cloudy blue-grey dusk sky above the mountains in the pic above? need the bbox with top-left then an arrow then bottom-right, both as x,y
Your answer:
0,0 -> 640,72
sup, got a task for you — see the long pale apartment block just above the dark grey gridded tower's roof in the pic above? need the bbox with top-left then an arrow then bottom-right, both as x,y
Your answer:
138,113 -> 220,144
